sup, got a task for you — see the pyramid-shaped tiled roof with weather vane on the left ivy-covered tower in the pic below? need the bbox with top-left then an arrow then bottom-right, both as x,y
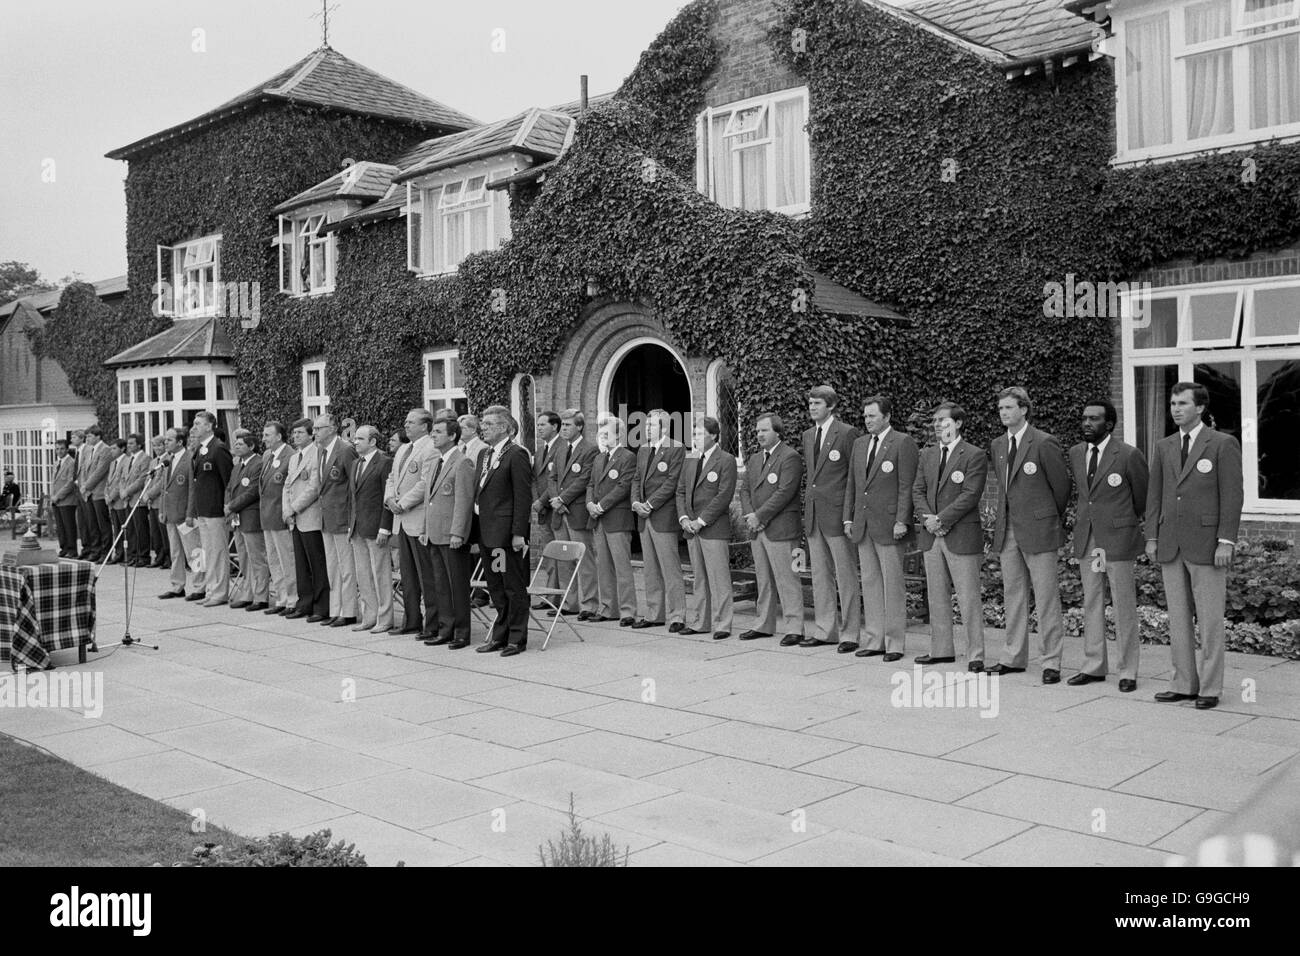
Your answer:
108,47 -> 478,159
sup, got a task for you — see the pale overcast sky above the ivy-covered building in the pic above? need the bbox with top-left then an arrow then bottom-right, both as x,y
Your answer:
0,0 -> 685,281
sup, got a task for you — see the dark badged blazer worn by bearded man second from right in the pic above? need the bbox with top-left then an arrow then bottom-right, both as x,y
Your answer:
1070,434 -> 1148,561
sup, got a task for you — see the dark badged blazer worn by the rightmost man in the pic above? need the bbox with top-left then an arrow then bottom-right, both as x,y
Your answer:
1147,425 -> 1244,564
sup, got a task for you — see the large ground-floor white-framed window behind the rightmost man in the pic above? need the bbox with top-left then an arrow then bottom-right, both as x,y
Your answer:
1121,277 -> 1300,515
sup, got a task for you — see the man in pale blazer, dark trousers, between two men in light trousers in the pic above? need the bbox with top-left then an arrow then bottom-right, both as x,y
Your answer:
280,419 -> 330,624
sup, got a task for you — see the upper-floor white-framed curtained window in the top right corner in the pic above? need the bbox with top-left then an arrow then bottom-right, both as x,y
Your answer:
1114,0 -> 1300,163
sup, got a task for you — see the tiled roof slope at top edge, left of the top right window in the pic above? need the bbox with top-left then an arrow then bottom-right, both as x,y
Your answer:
906,0 -> 1096,60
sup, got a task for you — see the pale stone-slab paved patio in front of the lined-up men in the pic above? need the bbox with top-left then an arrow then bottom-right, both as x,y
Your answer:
0,570 -> 1300,866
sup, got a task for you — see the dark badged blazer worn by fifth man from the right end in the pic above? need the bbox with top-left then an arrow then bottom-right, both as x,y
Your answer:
844,427 -> 920,546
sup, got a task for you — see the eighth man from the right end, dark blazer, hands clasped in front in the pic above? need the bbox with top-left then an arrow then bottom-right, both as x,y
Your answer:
677,415 -> 736,641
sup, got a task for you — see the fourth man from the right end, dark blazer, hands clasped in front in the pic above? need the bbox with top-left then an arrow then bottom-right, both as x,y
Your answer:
915,402 -> 988,674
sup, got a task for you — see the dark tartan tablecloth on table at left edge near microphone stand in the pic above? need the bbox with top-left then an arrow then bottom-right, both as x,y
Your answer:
0,561 -> 95,669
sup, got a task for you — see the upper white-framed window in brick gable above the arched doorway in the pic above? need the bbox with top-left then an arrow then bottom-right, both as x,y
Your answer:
696,87 -> 813,215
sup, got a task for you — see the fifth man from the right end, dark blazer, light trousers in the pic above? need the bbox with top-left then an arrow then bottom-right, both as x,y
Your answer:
839,395 -> 920,663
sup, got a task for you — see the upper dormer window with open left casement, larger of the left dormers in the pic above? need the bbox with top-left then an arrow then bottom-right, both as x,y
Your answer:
407,172 -> 510,276
